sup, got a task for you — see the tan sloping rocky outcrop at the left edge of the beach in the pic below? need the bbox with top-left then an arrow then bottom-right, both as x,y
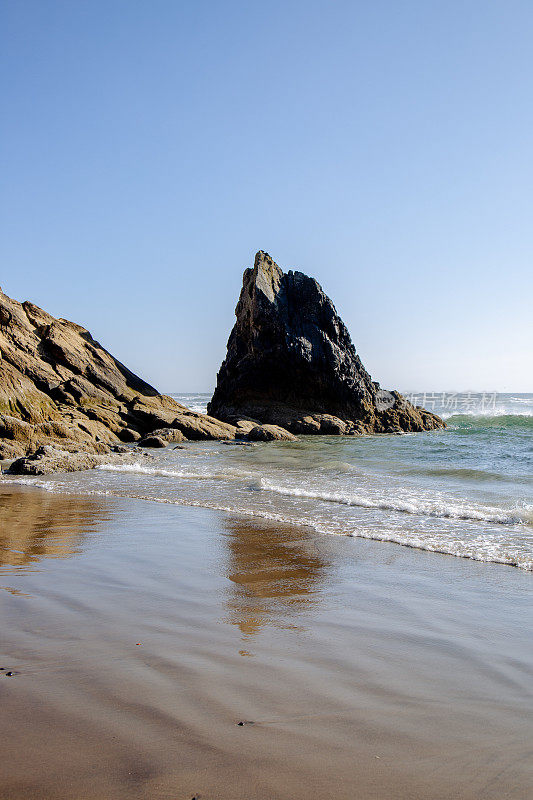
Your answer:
0,290 -> 236,459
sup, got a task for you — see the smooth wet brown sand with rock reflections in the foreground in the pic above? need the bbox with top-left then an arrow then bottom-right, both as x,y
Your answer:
0,486 -> 533,800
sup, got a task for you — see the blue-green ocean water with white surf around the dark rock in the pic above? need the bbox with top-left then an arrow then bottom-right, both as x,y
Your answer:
2,392 -> 533,570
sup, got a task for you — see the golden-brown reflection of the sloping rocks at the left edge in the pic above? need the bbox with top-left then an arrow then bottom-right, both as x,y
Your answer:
0,488 -> 109,571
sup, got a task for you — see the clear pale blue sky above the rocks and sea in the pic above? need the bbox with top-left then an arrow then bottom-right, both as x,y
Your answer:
0,0 -> 533,392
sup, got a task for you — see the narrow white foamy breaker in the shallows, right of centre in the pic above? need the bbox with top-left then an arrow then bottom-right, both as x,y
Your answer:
258,478 -> 527,525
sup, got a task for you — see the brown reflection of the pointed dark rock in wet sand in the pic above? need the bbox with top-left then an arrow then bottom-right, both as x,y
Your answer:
220,520 -> 328,634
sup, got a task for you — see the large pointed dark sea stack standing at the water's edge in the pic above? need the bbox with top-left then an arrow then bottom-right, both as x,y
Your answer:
208,250 -> 444,434
